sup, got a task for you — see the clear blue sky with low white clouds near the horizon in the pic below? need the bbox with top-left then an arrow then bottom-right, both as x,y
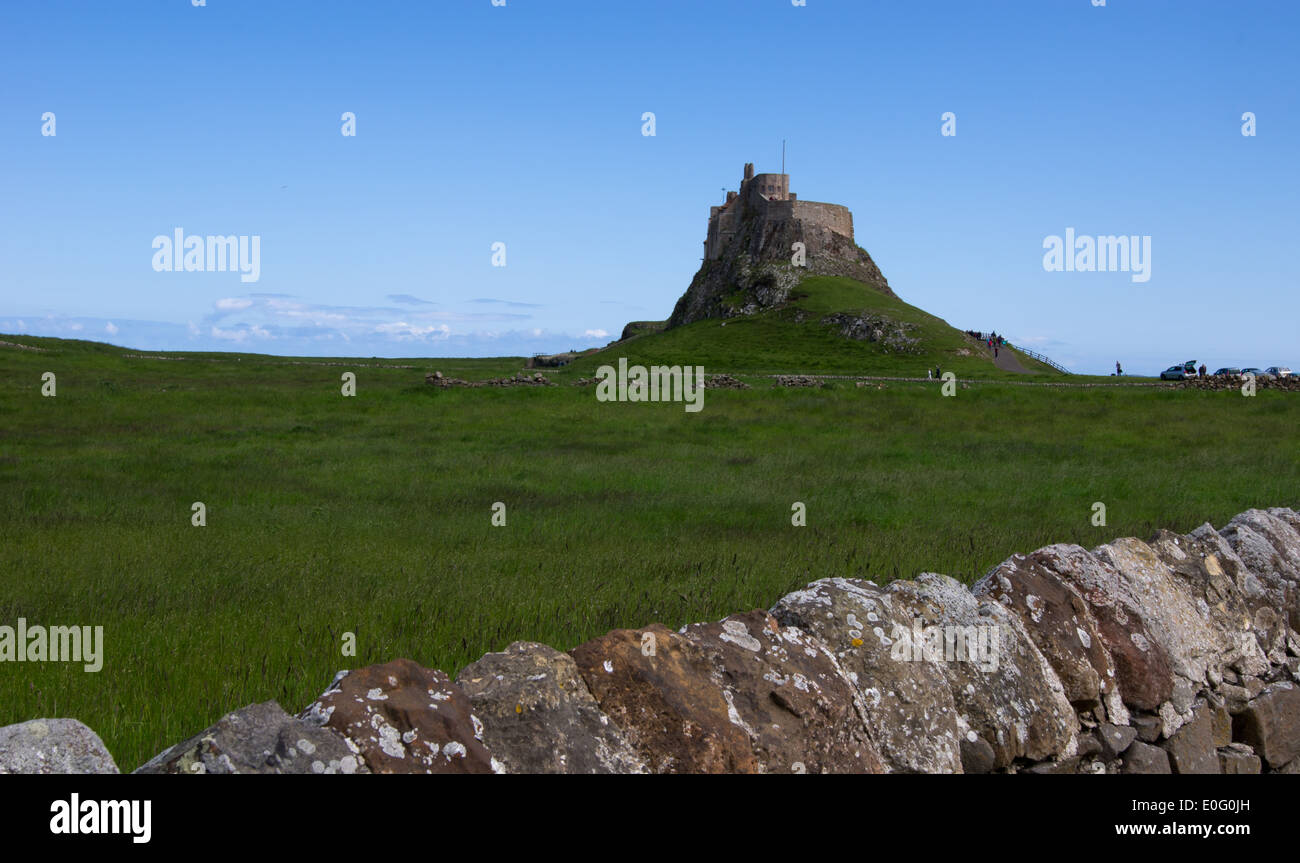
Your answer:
0,0 -> 1300,372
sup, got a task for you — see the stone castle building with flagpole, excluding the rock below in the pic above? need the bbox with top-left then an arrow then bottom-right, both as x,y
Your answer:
705,162 -> 854,261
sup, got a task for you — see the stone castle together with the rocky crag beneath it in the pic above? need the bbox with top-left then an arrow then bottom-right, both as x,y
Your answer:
667,162 -> 896,328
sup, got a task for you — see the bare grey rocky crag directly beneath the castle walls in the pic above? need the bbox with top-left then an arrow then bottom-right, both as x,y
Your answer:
668,211 -> 896,328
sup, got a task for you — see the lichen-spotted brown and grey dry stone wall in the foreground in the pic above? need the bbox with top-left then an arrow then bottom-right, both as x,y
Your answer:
0,508 -> 1300,773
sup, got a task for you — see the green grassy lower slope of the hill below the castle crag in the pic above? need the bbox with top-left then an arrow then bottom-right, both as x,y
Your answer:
568,276 -> 1060,380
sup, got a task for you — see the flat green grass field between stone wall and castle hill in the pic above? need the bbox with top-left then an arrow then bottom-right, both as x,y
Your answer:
0,325 -> 1300,769
